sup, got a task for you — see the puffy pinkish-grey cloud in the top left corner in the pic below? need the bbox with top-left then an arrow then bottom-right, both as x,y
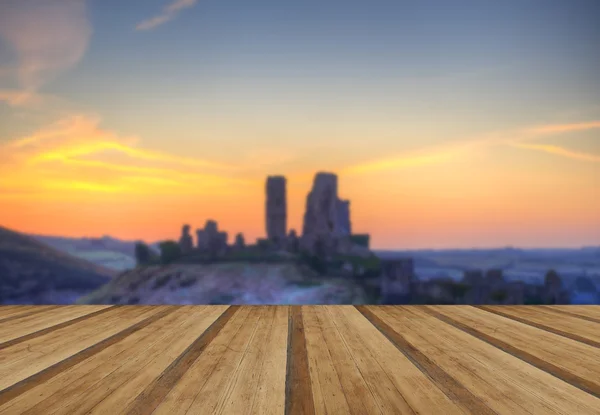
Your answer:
0,0 -> 92,106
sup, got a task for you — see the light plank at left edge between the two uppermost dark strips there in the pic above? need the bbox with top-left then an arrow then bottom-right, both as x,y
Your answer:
0,305 -> 112,349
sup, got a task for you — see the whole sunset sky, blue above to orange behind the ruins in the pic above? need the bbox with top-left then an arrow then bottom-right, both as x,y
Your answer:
0,0 -> 600,249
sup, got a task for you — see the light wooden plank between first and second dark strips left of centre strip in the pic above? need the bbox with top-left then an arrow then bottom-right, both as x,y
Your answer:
25,306 -> 227,415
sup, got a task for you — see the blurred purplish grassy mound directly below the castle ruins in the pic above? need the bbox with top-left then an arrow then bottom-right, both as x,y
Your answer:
78,262 -> 372,304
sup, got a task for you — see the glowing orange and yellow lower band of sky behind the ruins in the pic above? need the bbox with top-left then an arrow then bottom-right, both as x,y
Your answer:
0,117 -> 600,248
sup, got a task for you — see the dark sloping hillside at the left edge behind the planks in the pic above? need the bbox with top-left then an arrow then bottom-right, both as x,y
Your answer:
0,227 -> 114,304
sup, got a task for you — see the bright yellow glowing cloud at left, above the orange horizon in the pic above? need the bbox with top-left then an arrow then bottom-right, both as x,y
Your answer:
0,115 -> 254,195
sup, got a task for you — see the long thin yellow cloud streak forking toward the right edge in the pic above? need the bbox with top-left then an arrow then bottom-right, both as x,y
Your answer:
343,121 -> 600,174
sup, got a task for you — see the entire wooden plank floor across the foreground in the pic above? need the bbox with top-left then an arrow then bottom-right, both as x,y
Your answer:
0,306 -> 600,415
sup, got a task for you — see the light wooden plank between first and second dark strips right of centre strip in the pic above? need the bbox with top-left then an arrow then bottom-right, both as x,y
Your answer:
370,307 -> 600,415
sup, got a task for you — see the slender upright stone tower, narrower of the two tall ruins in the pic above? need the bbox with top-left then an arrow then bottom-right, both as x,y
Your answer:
266,176 -> 287,245
